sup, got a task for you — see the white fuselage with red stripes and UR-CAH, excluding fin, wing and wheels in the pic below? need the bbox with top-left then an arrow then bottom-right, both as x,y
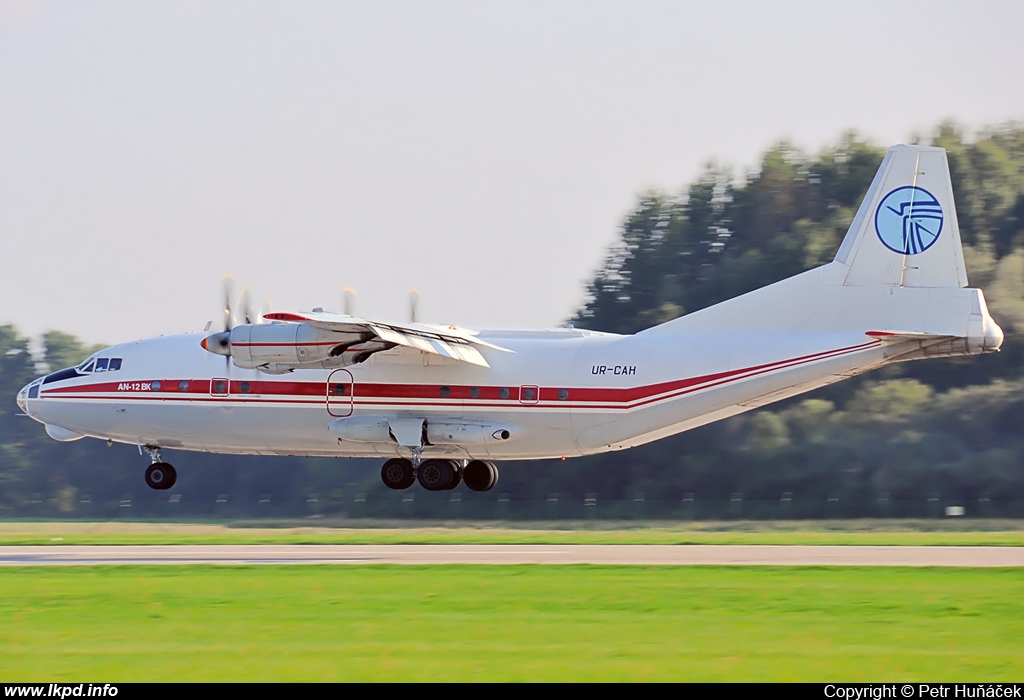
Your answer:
19,270 -> 1001,460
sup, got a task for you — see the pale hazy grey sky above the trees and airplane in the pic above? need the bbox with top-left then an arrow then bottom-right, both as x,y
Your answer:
0,0 -> 1024,343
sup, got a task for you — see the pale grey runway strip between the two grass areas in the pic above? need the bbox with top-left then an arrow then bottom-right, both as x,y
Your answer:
0,544 -> 1024,567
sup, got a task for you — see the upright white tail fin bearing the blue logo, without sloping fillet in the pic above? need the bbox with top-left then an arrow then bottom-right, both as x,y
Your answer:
835,145 -> 968,288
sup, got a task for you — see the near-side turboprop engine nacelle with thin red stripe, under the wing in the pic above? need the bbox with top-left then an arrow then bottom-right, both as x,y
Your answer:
202,323 -> 390,374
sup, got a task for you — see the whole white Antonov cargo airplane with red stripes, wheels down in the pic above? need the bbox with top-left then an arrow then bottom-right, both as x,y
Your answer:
17,145 -> 1002,491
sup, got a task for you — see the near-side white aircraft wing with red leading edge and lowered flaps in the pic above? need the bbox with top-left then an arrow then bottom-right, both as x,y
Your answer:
264,311 -> 511,367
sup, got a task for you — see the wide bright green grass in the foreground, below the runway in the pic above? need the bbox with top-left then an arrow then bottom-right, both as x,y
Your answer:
0,566 -> 1024,683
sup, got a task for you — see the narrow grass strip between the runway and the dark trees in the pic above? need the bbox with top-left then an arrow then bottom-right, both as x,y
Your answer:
0,520 -> 1024,546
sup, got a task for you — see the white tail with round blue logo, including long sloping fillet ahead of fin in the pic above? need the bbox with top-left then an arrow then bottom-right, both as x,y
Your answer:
641,145 -> 1002,352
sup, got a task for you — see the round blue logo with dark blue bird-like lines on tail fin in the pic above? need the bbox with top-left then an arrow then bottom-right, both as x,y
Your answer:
874,185 -> 942,255
